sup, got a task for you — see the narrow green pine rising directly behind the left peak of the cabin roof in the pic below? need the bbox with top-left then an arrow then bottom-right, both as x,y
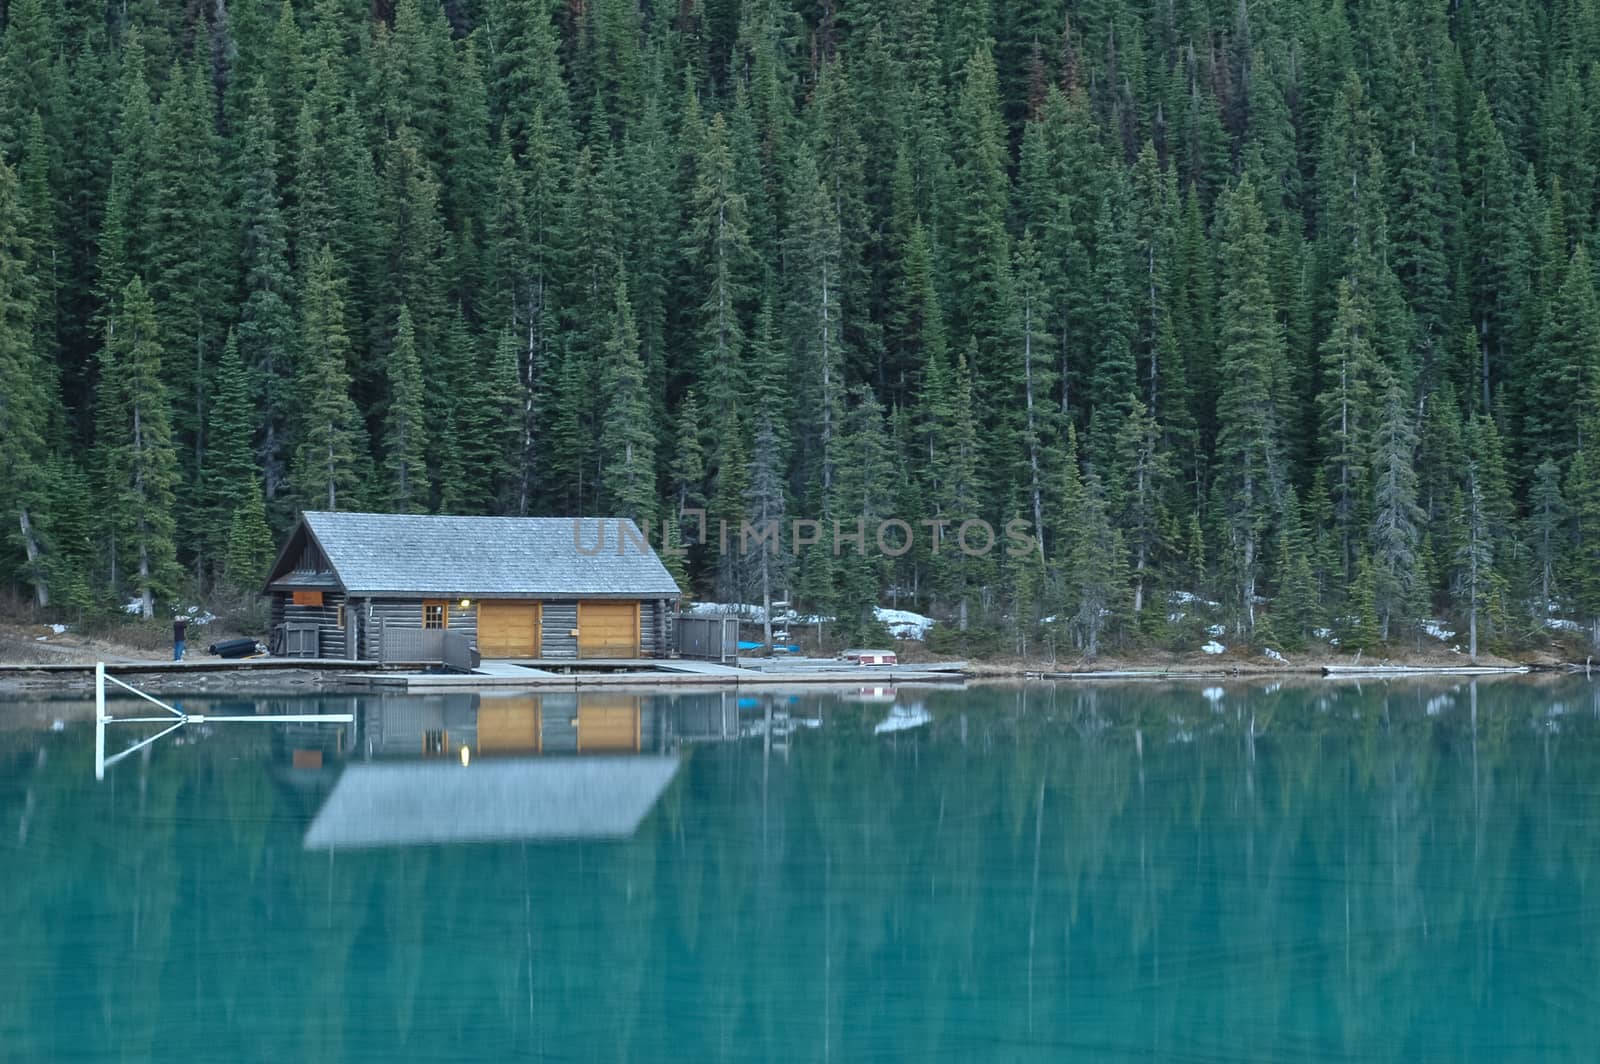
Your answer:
290,246 -> 370,510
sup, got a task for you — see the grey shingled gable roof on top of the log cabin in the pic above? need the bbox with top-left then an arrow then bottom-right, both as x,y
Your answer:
269,510 -> 678,598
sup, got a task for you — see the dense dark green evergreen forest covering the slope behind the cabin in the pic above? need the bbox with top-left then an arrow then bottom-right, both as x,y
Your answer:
0,0 -> 1600,656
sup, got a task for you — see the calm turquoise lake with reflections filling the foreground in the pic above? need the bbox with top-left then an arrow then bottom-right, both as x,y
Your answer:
0,677 -> 1600,1064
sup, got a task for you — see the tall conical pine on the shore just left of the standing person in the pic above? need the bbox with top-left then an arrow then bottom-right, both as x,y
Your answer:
98,277 -> 179,621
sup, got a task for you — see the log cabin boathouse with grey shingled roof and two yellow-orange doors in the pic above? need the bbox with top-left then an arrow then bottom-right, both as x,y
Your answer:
266,510 -> 678,661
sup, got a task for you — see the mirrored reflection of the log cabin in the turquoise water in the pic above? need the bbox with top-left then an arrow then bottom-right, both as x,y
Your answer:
294,693 -> 739,850
